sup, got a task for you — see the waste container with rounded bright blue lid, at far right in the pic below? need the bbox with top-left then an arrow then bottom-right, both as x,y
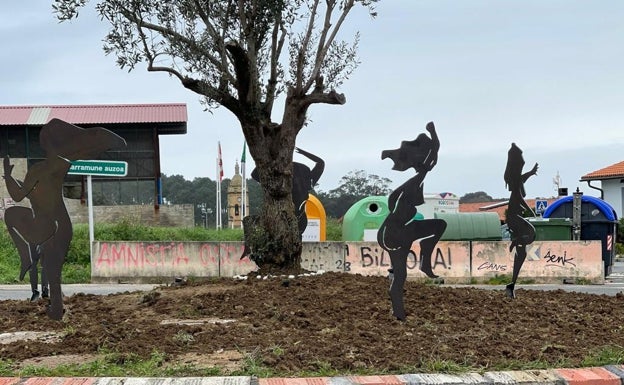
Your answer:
542,195 -> 618,277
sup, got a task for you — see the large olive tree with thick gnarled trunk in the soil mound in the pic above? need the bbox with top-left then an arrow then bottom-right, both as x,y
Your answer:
53,0 -> 379,269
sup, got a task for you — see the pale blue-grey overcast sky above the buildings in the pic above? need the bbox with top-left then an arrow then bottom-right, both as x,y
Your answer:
0,0 -> 624,198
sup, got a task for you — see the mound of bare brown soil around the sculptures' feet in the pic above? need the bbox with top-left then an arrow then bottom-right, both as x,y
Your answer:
0,273 -> 624,376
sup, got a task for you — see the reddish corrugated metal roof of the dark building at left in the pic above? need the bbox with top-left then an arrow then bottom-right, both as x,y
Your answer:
0,103 -> 187,134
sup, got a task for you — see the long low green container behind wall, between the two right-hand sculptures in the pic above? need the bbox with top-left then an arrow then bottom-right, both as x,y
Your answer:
434,212 -> 502,241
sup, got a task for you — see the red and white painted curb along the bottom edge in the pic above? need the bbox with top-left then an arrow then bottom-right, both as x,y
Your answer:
0,365 -> 624,385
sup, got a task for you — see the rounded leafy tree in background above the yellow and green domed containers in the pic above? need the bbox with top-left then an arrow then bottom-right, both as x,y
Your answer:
317,170 -> 392,218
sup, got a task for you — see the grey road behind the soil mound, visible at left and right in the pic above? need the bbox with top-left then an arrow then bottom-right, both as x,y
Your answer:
0,262 -> 624,301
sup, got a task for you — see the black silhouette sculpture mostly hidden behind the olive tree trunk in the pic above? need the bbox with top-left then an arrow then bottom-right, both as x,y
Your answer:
240,147 -> 325,259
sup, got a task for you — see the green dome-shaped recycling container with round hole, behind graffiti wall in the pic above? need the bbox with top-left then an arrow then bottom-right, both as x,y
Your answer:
342,196 -> 390,242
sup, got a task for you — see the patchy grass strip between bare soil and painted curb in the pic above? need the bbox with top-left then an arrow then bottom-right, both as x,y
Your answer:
0,345 -> 624,378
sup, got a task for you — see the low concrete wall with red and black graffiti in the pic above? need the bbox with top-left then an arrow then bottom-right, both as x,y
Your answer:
91,241 -> 604,283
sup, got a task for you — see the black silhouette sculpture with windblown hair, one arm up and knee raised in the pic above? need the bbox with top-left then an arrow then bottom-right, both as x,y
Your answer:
377,122 -> 446,320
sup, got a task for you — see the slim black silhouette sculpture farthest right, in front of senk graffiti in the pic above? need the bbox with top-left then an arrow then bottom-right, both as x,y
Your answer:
504,143 -> 538,298
